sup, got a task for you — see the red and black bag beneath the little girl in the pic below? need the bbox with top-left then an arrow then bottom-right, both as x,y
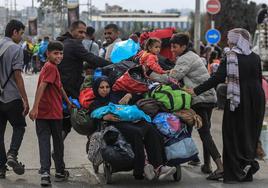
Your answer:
113,66 -> 148,93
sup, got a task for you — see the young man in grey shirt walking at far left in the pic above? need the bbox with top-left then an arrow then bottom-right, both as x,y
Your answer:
0,20 -> 29,178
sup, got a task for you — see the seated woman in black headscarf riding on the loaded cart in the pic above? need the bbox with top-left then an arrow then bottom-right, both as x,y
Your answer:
89,76 -> 176,180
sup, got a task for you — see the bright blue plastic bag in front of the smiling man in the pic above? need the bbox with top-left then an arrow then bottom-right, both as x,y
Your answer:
110,39 -> 140,63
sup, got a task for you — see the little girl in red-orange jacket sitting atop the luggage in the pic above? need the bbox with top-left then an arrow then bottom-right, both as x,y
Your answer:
140,38 -> 169,76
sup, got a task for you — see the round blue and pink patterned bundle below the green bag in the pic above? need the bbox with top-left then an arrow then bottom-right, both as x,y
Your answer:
153,112 -> 182,137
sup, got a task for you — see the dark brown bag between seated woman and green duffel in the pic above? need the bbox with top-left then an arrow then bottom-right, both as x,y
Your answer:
136,98 -> 168,118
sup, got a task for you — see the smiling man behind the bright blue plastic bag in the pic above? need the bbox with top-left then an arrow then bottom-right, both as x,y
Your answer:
104,24 -> 121,61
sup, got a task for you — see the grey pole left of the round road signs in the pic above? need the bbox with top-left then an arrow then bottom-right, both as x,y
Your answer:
194,0 -> 200,54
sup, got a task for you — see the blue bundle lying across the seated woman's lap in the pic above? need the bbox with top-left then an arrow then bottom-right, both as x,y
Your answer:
90,103 -> 151,122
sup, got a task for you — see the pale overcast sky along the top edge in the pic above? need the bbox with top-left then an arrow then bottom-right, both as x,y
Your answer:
0,0 -> 267,12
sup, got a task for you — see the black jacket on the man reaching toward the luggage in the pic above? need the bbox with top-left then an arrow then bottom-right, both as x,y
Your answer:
57,32 -> 110,98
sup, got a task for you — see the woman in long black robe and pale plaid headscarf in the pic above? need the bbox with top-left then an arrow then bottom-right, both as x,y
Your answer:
188,28 -> 265,183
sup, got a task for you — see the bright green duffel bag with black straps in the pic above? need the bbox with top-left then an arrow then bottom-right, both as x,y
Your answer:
148,85 -> 192,111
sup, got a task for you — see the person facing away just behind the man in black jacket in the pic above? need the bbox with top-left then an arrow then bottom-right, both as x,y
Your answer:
82,26 -> 99,55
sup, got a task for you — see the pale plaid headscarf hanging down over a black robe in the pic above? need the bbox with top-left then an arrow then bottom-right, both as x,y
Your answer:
226,28 -> 251,111
